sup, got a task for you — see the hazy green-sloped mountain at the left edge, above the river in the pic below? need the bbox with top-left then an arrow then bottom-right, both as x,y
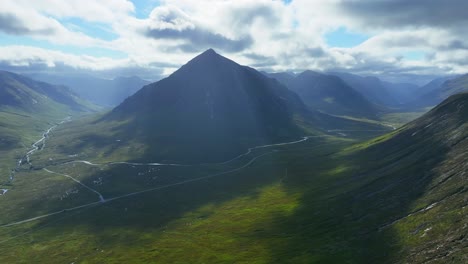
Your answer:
0,71 -> 97,175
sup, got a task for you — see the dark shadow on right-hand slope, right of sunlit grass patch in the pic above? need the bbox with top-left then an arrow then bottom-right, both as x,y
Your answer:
260,125 -> 454,263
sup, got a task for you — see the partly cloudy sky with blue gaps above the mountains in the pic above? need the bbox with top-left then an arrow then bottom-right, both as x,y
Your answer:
0,0 -> 468,83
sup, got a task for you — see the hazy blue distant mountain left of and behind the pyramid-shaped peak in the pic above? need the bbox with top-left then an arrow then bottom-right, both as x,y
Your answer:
30,73 -> 150,107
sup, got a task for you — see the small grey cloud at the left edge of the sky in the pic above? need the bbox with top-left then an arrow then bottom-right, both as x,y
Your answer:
0,13 -> 55,35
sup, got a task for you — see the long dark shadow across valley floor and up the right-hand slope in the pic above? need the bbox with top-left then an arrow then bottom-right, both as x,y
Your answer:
0,127 -> 454,263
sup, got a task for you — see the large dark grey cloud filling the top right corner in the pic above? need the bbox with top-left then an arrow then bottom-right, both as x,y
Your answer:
339,0 -> 468,28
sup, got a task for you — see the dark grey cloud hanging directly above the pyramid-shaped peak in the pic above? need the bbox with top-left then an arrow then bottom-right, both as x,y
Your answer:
145,28 -> 253,52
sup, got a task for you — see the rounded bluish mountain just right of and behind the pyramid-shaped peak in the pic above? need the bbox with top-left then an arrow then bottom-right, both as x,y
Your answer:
288,71 -> 379,118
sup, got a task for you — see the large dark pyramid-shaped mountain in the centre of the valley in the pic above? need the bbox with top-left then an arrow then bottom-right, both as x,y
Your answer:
107,49 -> 305,162
